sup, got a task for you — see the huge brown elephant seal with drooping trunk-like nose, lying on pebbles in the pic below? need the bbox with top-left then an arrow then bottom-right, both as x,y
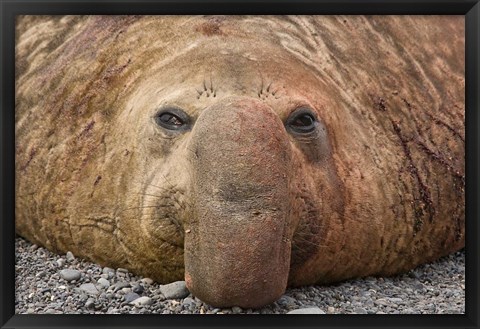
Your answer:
15,16 -> 465,308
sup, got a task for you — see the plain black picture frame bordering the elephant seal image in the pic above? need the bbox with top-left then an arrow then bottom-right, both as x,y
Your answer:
0,0 -> 480,328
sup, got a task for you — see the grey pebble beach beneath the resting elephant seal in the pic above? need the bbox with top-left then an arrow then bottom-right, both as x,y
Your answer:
15,234 -> 465,314
